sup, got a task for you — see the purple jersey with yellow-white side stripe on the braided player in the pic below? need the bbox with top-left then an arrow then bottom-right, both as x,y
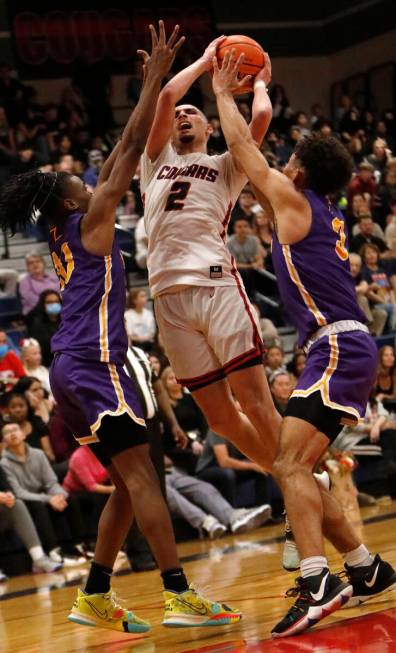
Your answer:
49,213 -> 128,365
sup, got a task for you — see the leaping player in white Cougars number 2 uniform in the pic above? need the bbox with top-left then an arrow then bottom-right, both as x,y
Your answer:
141,37 -> 280,470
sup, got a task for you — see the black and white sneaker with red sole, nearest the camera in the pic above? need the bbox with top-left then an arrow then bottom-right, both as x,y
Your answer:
271,568 -> 353,637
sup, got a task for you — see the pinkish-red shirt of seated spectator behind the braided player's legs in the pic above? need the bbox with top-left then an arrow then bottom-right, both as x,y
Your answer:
62,445 -> 110,493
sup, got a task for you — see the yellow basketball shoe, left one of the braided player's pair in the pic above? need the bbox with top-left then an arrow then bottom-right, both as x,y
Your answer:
68,589 -> 150,633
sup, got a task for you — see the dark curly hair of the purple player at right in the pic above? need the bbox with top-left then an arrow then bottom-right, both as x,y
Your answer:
294,134 -> 353,195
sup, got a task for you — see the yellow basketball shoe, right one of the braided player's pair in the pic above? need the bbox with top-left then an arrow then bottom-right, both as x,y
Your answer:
162,585 -> 242,628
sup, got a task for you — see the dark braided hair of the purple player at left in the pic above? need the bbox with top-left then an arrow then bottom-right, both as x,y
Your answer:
0,170 -> 70,236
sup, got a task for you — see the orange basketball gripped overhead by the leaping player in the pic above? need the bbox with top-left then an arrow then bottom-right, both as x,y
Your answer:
217,34 -> 265,95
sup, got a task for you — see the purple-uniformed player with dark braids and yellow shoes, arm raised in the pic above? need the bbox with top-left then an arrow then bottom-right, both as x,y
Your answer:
0,21 -> 241,633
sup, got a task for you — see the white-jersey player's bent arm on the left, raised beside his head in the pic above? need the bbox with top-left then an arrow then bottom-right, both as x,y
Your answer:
147,36 -> 225,161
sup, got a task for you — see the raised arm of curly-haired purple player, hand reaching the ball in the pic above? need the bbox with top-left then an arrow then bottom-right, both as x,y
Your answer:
213,53 -> 311,244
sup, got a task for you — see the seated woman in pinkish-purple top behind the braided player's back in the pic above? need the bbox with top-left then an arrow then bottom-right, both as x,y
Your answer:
19,254 -> 59,315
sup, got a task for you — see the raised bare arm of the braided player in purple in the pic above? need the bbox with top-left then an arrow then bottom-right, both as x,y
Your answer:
81,21 -> 184,256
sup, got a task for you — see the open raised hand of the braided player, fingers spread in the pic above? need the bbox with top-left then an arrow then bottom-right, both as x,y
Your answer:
137,20 -> 186,79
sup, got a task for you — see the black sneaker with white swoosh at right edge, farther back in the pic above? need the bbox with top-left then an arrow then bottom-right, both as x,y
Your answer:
341,553 -> 396,608
